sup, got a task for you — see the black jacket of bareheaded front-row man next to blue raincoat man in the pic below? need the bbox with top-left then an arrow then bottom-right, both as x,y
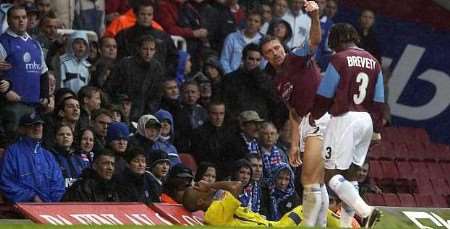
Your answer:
63,168 -> 120,202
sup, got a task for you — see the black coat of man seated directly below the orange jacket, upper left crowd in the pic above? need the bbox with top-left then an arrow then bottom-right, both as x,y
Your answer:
107,56 -> 164,121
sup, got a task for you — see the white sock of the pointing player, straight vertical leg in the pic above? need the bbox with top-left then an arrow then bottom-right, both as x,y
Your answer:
303,184 -> 322,227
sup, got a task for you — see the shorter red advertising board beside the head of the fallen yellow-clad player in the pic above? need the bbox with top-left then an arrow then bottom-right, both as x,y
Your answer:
150,203 -> 204,225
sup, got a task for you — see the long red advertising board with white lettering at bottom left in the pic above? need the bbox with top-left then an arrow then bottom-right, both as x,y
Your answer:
15,202 -> 173,225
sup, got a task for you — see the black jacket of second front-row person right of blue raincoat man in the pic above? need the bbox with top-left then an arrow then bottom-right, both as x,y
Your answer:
117,168 -> 161,204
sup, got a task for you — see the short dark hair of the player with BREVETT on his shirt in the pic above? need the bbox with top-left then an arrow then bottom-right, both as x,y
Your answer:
328,23 -> 360,49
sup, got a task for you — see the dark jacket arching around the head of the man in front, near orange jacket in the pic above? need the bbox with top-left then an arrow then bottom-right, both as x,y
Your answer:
116,24 -> 177,76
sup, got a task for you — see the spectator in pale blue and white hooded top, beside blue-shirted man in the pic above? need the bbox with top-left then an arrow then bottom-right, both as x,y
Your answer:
59,31 -> 91,93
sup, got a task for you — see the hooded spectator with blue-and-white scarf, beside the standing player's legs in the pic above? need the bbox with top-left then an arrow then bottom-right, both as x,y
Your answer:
267,163 -> 301,221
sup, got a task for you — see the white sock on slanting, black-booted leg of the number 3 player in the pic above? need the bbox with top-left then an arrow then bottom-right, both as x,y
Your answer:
328,174 -> 373,218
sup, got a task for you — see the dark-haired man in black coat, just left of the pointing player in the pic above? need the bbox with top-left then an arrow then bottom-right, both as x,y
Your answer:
222,44 -> 283,124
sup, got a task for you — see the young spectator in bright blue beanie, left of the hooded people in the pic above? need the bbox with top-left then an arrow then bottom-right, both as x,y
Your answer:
106,122 -> 130,174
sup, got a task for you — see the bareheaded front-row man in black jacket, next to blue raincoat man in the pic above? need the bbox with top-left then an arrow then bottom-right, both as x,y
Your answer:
63,150 -> 120,202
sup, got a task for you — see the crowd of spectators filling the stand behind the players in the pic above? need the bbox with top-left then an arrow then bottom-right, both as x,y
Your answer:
0,0 -> 379,220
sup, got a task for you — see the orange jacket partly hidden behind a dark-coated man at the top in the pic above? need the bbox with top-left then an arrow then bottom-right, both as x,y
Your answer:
103,9 -> 164,37
